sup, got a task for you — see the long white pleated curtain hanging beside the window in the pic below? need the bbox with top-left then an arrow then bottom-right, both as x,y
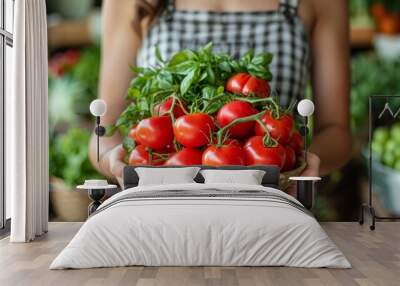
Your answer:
6,0 -> 49,242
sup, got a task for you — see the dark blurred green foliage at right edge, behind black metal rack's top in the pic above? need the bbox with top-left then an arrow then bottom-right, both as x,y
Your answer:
351,54 -> 400,130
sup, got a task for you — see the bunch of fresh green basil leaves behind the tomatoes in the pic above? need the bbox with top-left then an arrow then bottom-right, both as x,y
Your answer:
113,43 -> 272,137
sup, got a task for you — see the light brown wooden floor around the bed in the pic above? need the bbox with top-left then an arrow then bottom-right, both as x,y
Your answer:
0,222 -> 400,286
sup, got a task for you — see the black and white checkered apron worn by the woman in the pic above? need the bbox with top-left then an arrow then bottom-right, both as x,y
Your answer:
137,0 -> 310,106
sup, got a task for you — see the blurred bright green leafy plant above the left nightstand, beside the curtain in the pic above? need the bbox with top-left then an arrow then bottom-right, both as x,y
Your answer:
49,128 -> 101,187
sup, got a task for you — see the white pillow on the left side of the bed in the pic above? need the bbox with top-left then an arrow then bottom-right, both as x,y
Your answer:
135,167 -> 200,186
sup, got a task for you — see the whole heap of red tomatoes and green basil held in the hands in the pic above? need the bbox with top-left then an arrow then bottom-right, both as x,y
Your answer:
108,44 -> 303,171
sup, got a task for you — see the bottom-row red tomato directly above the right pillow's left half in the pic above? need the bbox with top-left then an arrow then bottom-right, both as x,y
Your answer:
202,145 -> 246,166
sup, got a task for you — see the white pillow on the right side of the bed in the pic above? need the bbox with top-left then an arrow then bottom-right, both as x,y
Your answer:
200,169 -> 265,185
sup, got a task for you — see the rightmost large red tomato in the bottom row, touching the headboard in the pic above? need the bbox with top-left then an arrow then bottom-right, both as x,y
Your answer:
243,136 -> 286,168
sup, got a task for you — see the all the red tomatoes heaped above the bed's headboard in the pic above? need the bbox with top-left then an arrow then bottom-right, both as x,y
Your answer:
128,73 -> 303,171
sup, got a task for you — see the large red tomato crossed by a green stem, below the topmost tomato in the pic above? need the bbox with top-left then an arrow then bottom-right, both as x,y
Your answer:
217,100 -> 257,138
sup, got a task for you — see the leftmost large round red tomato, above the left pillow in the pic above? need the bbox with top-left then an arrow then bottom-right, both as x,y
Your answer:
136,116 -> 174,150
